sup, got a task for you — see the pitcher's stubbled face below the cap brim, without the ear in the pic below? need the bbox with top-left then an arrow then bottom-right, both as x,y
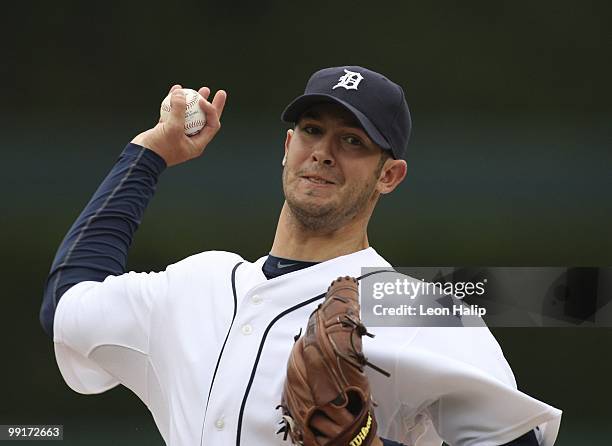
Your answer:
283,104 -> 382,231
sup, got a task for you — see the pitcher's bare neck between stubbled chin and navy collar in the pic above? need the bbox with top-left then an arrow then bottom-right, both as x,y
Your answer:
270,202 -> 370,262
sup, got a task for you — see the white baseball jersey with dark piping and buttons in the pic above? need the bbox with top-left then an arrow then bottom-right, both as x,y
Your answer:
54,248 -> 561,446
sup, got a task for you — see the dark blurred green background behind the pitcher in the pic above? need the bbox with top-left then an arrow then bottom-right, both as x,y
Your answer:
0,0 -> 612,446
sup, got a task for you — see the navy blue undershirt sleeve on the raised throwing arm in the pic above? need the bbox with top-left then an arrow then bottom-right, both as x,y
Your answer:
40,144 -> 166,338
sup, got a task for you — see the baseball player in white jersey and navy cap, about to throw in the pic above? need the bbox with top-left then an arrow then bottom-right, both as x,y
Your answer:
41,66 -> 561,446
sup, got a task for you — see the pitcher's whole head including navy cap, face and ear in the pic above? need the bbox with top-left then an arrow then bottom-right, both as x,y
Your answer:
282,67 -> 410,232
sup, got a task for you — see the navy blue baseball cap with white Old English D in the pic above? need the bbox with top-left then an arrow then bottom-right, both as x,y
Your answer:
281,66 -> 412,159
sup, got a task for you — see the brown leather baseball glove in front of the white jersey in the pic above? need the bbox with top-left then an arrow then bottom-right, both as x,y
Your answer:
277,276 -> 389,446
